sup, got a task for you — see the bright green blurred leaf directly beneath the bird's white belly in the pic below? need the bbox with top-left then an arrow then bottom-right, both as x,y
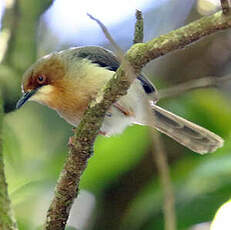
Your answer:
81,127 -> 150,193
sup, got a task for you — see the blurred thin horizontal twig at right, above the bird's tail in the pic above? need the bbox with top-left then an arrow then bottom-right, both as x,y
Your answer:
158,75 -> 231,99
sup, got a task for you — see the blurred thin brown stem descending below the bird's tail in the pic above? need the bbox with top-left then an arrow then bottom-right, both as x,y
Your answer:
151,130 -> 176,230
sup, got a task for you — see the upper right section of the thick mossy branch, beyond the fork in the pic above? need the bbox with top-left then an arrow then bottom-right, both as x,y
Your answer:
127,11 -> 231,73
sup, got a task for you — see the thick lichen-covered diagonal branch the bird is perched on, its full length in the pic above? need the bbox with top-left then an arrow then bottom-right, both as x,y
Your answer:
45,11 -> 231,230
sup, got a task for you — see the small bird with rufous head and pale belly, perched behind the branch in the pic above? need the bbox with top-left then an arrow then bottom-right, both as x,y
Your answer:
16,46 -> 223,154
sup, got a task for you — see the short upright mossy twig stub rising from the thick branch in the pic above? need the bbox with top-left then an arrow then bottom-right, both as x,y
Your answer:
133,10 -> 144,44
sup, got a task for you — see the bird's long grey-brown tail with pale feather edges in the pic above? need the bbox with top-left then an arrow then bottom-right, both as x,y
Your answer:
152,105 -> 224,154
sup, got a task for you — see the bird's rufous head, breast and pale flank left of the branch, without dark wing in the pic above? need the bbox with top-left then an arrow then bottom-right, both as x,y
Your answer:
16,48 -> 114,123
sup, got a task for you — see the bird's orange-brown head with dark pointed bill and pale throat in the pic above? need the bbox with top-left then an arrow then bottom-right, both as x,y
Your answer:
16,53 -> 67,109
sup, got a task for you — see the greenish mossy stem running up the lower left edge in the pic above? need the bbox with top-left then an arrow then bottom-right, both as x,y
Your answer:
0,97 -> 17,230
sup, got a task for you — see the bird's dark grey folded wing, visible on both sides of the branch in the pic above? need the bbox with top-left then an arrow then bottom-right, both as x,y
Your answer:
71,46 -> 157,94
